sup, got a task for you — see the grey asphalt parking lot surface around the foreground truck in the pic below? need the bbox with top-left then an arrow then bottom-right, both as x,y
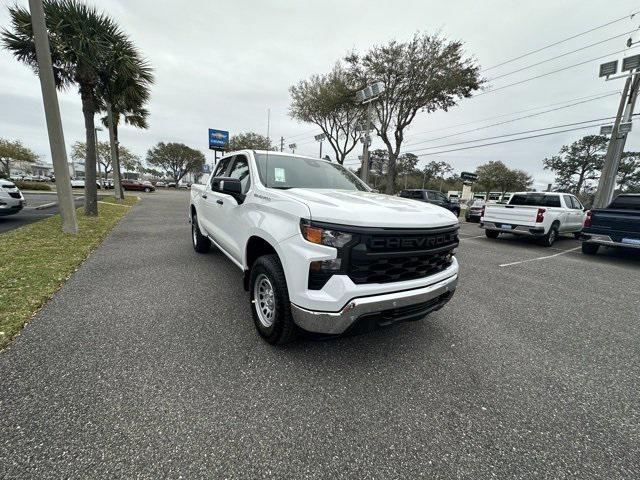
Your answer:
0,191 -> 640,479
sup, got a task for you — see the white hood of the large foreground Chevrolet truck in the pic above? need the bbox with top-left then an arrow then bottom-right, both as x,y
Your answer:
279,188 -> 458,228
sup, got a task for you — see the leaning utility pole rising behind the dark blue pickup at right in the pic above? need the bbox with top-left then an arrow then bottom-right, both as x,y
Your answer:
593,73 -> 640,208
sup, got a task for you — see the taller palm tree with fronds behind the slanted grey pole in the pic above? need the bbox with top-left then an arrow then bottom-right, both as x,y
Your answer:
0,0 -> 127,215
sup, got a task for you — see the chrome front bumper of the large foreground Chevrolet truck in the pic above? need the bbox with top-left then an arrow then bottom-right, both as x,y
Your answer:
291,274 -> 458,335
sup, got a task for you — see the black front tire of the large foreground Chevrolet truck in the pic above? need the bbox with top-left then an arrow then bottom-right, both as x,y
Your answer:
249,254 -> 296,345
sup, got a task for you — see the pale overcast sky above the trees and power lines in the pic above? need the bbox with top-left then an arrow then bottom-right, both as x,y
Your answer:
0,0 -> 640,188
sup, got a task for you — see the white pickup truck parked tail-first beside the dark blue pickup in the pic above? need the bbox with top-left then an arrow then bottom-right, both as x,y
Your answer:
480,192 -> 586,247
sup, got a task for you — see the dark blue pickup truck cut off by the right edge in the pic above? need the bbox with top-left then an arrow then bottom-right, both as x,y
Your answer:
582,193 -> 640,255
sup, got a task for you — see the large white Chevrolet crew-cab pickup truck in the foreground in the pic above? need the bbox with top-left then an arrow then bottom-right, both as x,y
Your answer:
189,150 -> 458,344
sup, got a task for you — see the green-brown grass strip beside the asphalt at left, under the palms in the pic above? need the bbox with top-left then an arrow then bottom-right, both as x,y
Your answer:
0,197 -> 138,350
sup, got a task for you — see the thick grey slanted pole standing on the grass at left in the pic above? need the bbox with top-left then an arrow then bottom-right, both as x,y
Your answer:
29,0 -> 78,234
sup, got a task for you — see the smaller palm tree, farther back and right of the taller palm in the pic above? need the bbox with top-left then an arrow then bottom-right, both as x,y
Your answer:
99,41 -> 153,200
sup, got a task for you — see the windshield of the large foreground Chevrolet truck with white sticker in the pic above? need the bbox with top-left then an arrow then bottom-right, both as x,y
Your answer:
255,153 -> 369,191
